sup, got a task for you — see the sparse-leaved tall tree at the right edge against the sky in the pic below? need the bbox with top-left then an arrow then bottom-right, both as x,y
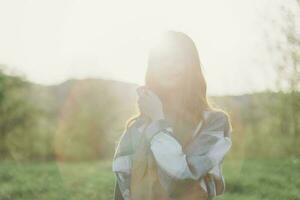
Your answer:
269,0 -> 300,151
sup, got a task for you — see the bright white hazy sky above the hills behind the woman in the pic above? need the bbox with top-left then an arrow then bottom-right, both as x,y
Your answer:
0,0 -> 288,95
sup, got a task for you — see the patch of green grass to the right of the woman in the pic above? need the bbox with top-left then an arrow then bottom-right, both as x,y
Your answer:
217,158 -> 300,200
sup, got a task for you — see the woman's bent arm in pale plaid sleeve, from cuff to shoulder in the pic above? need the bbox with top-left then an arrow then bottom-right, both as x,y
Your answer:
146,112 -> 231,180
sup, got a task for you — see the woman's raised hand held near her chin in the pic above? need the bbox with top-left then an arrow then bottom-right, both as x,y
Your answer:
138,87 -> 164,121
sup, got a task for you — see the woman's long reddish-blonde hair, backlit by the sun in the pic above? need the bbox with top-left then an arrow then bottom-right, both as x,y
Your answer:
126,31 -> 213,144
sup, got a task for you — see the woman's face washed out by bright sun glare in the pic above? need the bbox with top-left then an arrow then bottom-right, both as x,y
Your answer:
150,48 -> 185,89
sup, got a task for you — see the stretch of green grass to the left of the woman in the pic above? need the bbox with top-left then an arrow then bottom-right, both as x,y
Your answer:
0,159 -> 114,200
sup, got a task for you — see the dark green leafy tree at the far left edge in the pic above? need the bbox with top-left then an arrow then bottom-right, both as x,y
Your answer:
0,65 -> 42,159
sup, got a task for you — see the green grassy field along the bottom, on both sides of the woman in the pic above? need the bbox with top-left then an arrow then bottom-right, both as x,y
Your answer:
0,158 -> 300,200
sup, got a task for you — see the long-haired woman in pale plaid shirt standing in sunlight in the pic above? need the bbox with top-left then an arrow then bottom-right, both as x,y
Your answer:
113,31 -> 232,200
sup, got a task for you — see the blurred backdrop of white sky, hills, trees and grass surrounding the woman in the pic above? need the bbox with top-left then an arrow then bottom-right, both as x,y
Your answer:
0,0 -> 300,200
